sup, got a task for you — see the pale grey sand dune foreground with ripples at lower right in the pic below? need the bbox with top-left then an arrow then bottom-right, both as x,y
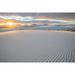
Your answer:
0,30 -> 75,62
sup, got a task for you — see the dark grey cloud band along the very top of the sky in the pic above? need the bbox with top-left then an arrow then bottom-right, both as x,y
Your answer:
0,13 -> 75,18
